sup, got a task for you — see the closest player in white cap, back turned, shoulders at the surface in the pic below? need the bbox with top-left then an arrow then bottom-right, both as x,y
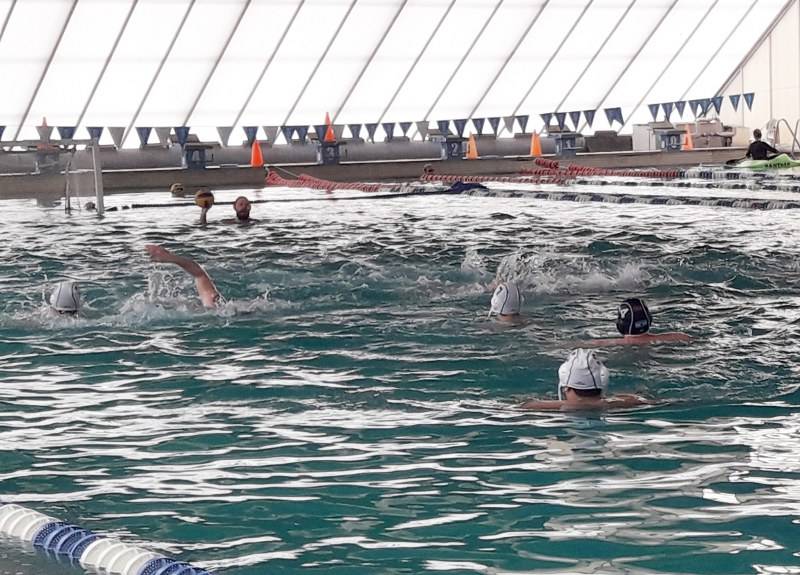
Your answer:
520,349 -> 650,411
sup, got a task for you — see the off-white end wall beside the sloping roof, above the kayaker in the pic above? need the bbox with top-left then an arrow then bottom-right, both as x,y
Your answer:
720,0 -> 800,144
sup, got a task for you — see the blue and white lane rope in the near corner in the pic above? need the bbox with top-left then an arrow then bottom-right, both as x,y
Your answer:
0,504 -> 212,575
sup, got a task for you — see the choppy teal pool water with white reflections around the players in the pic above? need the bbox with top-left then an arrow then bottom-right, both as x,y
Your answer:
0,187 -> 800,575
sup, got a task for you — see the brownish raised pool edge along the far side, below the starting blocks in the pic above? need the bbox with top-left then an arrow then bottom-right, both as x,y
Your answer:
0,148 -> 744,199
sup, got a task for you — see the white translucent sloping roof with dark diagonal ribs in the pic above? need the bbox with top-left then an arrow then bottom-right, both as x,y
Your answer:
0,0 -> 786,145
